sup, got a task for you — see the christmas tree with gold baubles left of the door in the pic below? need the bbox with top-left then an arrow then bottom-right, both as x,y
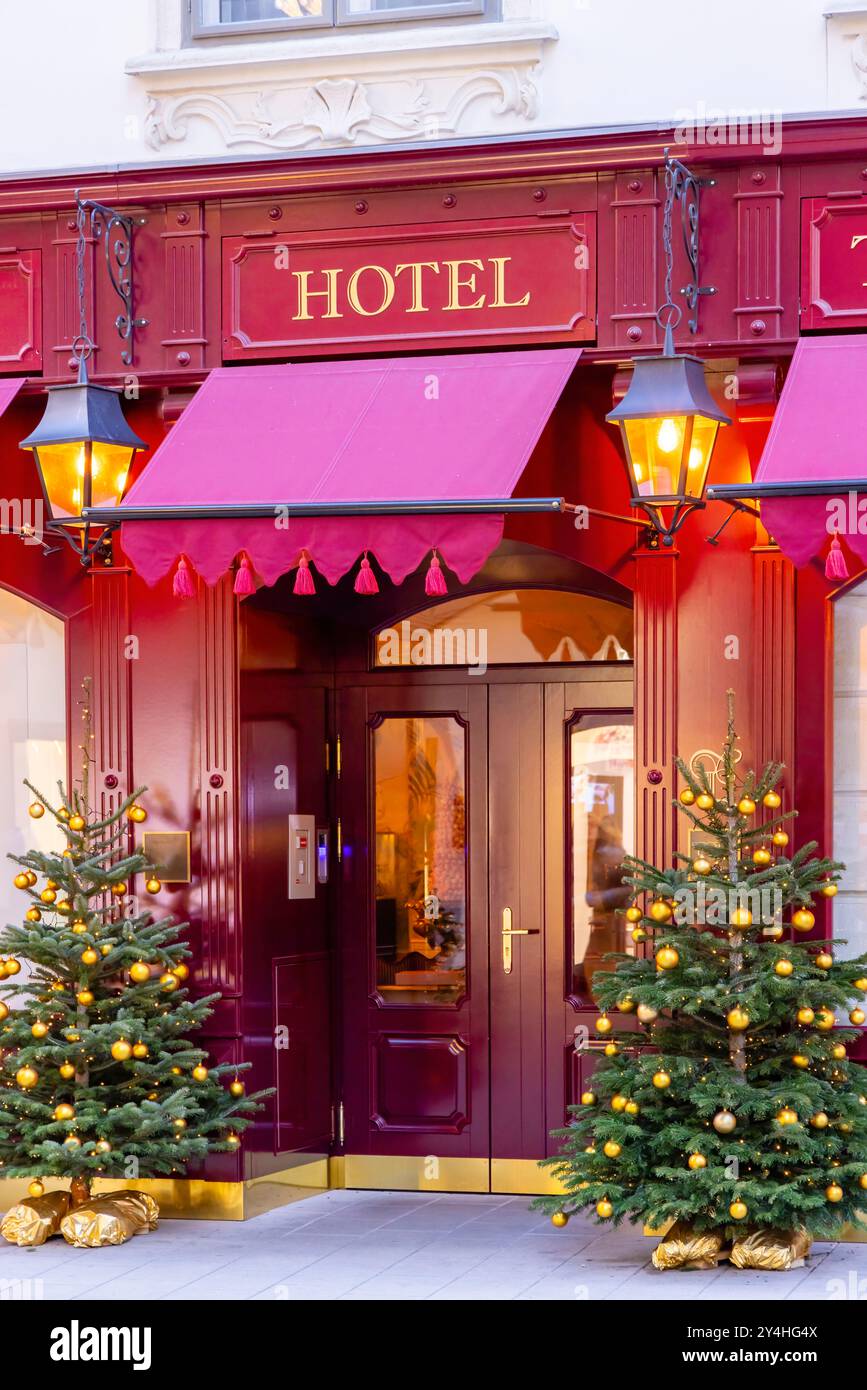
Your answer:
0,681 -> 264,1198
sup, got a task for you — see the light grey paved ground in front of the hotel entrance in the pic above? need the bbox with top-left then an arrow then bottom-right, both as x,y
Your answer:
0,1191 -> 867,1302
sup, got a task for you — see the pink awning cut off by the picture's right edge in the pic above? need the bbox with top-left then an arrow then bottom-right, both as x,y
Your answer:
707,334 -> 867,578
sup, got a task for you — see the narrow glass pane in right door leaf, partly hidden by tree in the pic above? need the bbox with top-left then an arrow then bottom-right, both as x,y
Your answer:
570,714 -> 635,998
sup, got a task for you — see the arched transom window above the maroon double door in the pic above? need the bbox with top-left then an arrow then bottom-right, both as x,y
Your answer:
374,589 -> 634,670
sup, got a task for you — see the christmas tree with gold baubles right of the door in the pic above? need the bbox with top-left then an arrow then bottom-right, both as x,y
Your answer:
535,692 -> 867,1240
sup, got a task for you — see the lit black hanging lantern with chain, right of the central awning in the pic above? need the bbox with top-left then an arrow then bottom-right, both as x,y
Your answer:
606,160 -> 731,545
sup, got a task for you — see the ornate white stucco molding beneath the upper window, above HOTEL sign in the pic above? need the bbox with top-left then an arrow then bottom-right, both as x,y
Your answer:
126,18 -> 557,153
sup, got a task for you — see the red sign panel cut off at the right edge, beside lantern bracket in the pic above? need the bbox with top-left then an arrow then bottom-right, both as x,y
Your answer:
800,196 -> 867,331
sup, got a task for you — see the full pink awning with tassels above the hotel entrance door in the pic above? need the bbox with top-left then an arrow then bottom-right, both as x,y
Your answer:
119,348 -> 579,584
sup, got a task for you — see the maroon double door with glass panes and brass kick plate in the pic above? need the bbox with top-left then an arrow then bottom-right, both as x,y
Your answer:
335,664 -> 632,1193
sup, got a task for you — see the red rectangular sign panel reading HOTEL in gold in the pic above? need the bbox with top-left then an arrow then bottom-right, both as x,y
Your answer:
222,213 -> 596,361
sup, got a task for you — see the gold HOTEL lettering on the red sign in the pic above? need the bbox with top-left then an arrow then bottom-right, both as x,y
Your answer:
292,256 -> 531,321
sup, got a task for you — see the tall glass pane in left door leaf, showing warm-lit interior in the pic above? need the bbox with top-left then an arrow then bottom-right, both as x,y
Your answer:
374,714 -> 467,1005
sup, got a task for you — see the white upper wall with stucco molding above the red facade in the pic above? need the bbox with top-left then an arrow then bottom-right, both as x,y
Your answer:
0,0 -> 867,174
